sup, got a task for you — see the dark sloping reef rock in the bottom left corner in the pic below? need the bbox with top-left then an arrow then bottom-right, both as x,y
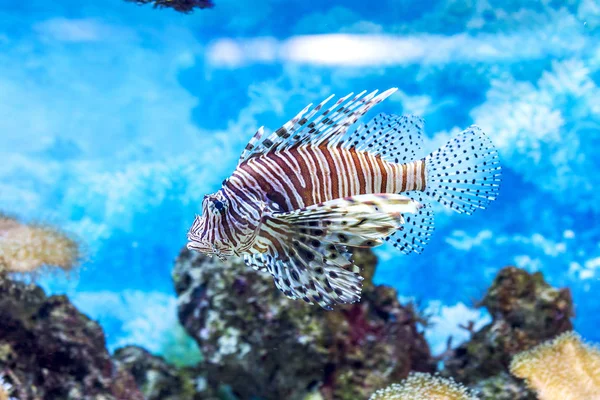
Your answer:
0,276 -> 144,400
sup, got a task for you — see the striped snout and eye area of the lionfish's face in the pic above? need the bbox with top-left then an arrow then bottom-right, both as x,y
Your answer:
187,191 -> 234,260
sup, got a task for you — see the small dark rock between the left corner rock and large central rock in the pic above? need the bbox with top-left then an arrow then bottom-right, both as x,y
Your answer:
113,346 -> 216,400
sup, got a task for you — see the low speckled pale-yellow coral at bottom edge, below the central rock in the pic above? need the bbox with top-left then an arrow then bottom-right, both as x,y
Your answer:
369,372 -> 477,400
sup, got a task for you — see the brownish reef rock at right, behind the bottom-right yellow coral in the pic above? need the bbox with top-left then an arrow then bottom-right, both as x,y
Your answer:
443,267 -> 574,400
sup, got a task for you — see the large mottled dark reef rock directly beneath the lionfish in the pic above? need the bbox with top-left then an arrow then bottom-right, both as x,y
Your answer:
173,249 -> 435,400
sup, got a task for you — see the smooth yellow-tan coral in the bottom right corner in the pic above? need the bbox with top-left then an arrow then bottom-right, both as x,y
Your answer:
510,332 -> 600,400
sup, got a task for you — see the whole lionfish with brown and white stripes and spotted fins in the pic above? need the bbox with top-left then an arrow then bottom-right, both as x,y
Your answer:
187,88 -> 501,310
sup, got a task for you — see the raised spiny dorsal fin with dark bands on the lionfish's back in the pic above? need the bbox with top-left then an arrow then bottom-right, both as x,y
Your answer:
239,88 -> 397,164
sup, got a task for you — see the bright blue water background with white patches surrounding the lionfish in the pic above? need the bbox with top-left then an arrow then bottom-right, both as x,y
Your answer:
0,0 -> 600,352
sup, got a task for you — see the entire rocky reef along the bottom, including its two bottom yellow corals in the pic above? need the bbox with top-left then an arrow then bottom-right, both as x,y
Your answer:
0,238 -> 584,400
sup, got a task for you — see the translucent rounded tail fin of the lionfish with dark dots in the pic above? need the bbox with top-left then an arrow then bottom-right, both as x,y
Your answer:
425,125 -> 502,214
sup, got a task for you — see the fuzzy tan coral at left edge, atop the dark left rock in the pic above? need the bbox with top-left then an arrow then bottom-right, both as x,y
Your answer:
0,215 -> 80,273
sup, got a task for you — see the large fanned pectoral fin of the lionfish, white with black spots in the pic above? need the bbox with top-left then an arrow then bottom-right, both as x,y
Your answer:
247,194 -> 420,309
